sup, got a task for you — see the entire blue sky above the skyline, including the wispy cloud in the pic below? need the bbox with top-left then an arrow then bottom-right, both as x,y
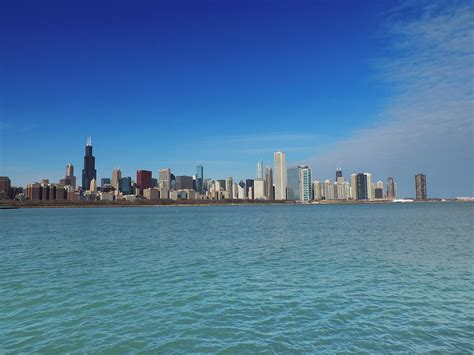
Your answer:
0,0 -> 474,197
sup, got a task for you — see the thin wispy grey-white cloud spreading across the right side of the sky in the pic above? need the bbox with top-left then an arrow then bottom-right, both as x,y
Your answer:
310,2 -> 474,196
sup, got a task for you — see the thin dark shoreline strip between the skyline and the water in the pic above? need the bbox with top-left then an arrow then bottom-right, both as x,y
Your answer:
0,199 -> 466,210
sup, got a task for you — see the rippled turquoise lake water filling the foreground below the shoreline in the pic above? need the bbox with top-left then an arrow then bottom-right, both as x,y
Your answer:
0,203 -> 474,353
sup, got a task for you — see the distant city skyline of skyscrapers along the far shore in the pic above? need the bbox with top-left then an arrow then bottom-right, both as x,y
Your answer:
0,138 -> 428,203
